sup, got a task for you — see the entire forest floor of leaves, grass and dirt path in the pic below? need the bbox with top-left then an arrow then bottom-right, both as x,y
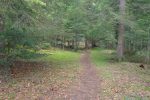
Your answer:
0,49 -> 150,100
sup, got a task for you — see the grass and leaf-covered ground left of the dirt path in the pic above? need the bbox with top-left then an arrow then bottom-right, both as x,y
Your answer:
0,49 -> 80,100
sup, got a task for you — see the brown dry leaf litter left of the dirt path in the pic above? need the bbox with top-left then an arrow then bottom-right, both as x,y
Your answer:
0,63 -> 79,100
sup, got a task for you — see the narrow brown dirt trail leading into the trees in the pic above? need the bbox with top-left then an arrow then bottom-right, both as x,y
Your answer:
69,51 -> 100,100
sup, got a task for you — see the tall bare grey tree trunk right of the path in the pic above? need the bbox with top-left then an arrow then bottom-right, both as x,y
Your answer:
117,0 -> 126,61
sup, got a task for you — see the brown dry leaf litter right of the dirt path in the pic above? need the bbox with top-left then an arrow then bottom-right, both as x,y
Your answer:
98,64 -> 150,100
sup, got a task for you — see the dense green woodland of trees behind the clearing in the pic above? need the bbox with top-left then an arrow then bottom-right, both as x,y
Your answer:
0,0 -> 150,63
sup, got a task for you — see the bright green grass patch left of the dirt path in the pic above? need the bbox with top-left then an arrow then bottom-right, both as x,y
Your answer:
25,49 -> 80,64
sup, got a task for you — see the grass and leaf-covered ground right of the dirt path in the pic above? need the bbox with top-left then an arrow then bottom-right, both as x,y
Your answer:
91,49 -> 150,100
